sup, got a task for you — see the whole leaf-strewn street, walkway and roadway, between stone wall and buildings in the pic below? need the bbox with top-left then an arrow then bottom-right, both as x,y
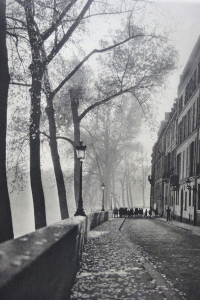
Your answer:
70,218 -> 200,300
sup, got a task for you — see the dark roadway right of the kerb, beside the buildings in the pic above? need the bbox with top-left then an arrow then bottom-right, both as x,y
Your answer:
123,220 -> 200,300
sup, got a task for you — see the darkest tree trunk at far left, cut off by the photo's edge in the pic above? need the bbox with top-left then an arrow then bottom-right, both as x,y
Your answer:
0,0 -> 13,242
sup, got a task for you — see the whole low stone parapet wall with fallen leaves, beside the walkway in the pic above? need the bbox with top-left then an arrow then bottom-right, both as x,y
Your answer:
0,211 -> 112,300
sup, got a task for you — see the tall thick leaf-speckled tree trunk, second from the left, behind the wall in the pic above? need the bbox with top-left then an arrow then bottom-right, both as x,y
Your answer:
24,1 -> 46,229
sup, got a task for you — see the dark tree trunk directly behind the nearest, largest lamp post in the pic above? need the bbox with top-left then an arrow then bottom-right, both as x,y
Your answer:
70,90 -> 80,207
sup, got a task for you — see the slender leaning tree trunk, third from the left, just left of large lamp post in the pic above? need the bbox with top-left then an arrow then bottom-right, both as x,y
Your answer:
46,96 -> 69,220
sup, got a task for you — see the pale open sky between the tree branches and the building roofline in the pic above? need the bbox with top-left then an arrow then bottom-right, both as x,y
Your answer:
139,0 -> 200,152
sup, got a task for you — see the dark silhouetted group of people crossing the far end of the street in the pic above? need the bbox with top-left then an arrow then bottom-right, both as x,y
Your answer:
113,207 -> 152,218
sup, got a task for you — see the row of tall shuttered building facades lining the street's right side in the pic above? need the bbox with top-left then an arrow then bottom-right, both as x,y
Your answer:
149,38 -> 200,225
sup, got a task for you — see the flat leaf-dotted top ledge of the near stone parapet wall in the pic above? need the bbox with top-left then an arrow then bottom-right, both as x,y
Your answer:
0,217 -> 86,287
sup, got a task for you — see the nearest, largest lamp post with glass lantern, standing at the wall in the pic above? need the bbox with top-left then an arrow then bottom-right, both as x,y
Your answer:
74,142 -> 87,216
